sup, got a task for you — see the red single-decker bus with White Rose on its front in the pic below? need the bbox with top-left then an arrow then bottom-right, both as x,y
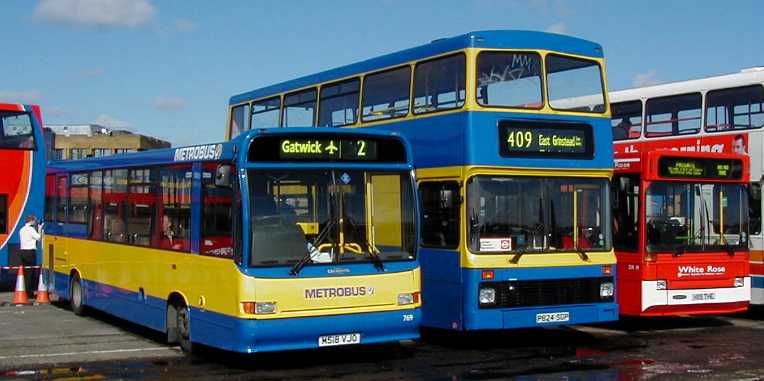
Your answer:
612,150 -> 751,316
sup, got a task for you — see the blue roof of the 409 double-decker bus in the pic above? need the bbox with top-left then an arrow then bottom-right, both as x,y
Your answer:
229,30 -> 603,105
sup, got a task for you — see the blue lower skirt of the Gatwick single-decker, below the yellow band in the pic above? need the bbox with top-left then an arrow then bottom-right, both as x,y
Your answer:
54,273 -> 421,353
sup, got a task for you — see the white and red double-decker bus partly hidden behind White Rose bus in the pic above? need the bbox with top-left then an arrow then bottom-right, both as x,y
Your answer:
610,67 -> 764,304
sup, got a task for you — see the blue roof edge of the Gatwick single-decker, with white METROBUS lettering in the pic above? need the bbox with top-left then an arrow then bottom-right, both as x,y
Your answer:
48,127 -> 412,173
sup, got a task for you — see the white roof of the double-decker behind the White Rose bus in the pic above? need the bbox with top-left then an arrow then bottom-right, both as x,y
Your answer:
608,67 -> 764,103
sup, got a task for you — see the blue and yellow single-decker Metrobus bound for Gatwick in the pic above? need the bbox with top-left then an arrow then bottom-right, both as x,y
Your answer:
44,129 -> 421,353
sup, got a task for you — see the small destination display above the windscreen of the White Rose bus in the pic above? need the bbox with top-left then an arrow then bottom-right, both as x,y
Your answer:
658,157 -> 743,180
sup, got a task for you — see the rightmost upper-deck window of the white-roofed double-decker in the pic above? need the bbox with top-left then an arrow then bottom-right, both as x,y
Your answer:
706,85 -> 764,131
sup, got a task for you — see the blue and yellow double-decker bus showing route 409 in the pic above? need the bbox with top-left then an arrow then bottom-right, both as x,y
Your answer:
227,31 -> 618,330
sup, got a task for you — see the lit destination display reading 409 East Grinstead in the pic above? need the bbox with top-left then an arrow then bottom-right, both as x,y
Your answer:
499,122 -> 592,157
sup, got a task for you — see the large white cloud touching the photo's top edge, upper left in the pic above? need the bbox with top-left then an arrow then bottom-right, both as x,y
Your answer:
33,0 -> 157,27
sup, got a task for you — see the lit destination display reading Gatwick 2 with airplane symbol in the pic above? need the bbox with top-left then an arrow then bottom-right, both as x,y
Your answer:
279,138 -> 377,161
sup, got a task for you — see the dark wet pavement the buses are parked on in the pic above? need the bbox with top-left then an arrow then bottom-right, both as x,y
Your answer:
0,298 -> 764,381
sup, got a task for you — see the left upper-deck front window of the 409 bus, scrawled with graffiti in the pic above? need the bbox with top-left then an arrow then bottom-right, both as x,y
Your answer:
477,52 -> 544,109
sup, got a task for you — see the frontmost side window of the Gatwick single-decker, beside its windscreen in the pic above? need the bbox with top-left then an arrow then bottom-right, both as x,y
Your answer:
199,163 -> 236,258
